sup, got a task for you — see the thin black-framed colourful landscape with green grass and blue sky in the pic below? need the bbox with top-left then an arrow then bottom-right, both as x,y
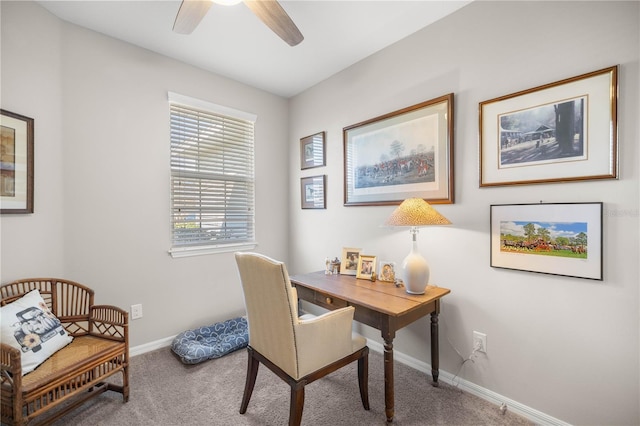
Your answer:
490,202 -> 603,281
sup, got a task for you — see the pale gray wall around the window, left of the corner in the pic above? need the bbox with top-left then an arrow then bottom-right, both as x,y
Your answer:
0,2 -> 289,346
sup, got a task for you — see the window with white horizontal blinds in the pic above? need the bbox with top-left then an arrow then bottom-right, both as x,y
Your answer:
169,93 -> 256,257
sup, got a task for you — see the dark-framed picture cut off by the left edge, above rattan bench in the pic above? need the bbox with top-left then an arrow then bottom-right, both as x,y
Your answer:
0,110 -> 34,214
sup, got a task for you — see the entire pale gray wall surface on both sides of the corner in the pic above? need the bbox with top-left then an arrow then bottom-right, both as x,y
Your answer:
0,1 -> 640,425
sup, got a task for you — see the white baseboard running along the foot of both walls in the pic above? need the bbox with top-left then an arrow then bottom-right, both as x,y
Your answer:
129,336 -> 570,426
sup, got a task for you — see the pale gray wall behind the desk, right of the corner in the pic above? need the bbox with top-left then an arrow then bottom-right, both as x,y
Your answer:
289,1 -> 640,425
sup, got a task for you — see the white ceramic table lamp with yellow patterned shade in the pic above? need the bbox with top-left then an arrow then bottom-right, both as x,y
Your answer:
385,198 -> 451,294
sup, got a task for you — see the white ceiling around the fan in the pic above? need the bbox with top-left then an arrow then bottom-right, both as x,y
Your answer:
38,0 -> 470,98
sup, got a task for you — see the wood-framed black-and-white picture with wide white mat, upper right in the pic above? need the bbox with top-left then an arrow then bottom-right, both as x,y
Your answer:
480,66 -> 618,187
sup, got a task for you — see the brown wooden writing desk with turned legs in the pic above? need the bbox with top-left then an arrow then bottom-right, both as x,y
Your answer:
290,271 -> 451,422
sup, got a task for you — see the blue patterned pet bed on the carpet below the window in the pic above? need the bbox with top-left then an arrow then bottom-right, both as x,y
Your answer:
171,317 -> 249,364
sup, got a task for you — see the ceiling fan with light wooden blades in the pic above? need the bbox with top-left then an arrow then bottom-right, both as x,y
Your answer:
173,0 -> 304,46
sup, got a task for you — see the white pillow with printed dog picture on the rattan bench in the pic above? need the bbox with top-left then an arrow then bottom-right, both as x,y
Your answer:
1,290 -> 73,376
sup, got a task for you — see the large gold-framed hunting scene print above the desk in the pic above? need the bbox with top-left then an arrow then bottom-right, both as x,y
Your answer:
343,93 -> 453,206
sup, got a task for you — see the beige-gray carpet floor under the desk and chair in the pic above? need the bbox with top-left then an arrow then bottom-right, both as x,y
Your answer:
54,348 -> 532,426
